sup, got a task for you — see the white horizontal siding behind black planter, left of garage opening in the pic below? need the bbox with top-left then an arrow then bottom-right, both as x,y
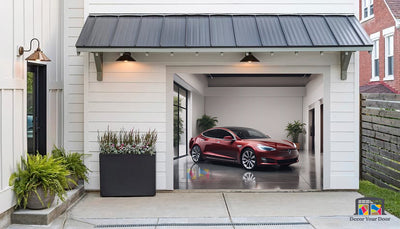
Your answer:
85,54 -> 168,190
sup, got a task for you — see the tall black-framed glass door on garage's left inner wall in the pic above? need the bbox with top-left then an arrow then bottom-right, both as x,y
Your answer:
174,83 -> 188,158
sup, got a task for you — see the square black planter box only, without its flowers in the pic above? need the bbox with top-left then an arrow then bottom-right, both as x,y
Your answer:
99,153 -> 156,197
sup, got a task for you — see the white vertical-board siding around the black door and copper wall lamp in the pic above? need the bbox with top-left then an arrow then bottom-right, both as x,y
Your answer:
0,0 -> 63,214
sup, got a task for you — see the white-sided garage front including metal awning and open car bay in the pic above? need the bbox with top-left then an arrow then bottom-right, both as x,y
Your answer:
76,14 -> 372,190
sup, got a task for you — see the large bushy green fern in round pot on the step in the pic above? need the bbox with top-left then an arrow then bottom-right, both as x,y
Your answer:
9,154 -> 69,209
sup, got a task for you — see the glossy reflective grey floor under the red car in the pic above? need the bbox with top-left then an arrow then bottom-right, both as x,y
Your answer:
174,151 -> 322,190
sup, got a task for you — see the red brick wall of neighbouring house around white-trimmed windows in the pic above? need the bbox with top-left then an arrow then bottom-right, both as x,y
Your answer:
359,0 -> 400,92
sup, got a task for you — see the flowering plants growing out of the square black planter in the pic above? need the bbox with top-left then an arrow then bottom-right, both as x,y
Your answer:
97,128 -> 157,155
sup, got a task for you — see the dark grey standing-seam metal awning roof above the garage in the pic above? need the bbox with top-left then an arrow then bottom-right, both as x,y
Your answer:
76,14 -> 372,52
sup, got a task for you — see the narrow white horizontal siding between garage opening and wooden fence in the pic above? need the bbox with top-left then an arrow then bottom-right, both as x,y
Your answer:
324,54 -> 359,189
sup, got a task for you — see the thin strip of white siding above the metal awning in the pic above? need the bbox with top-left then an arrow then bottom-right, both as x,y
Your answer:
87,0 -> 358,14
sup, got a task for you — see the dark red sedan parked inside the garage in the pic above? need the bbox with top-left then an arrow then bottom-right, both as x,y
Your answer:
189,127 -> 299,170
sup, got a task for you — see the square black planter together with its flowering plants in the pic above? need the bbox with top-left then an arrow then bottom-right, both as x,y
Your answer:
98,129 -> 157,196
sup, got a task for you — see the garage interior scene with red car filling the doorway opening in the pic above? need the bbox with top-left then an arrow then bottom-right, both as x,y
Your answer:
174,74 -> 323,190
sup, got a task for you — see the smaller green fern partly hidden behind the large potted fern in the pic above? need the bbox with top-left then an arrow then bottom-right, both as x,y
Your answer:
51,146 -> 90,189
